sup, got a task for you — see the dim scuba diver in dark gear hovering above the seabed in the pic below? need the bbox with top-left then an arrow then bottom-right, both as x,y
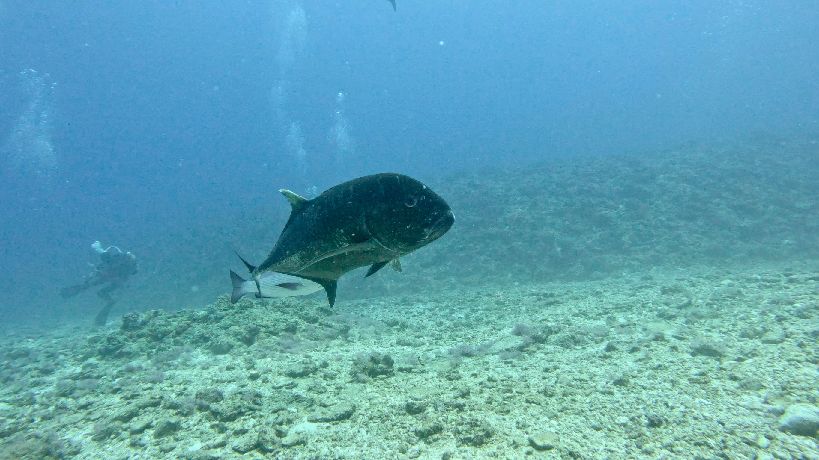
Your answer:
60,241 -> 137,326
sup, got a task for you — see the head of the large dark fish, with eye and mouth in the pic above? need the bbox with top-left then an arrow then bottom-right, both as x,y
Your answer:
365,174 -> 455,254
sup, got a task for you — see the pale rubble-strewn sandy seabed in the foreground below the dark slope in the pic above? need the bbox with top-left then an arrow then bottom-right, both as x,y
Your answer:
0,264 -> 819,459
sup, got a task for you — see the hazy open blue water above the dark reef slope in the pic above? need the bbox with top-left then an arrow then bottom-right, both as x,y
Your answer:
0,0 -> 819,322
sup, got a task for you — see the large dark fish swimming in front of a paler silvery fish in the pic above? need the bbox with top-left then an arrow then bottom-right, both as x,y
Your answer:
234,173 -> 455,306
